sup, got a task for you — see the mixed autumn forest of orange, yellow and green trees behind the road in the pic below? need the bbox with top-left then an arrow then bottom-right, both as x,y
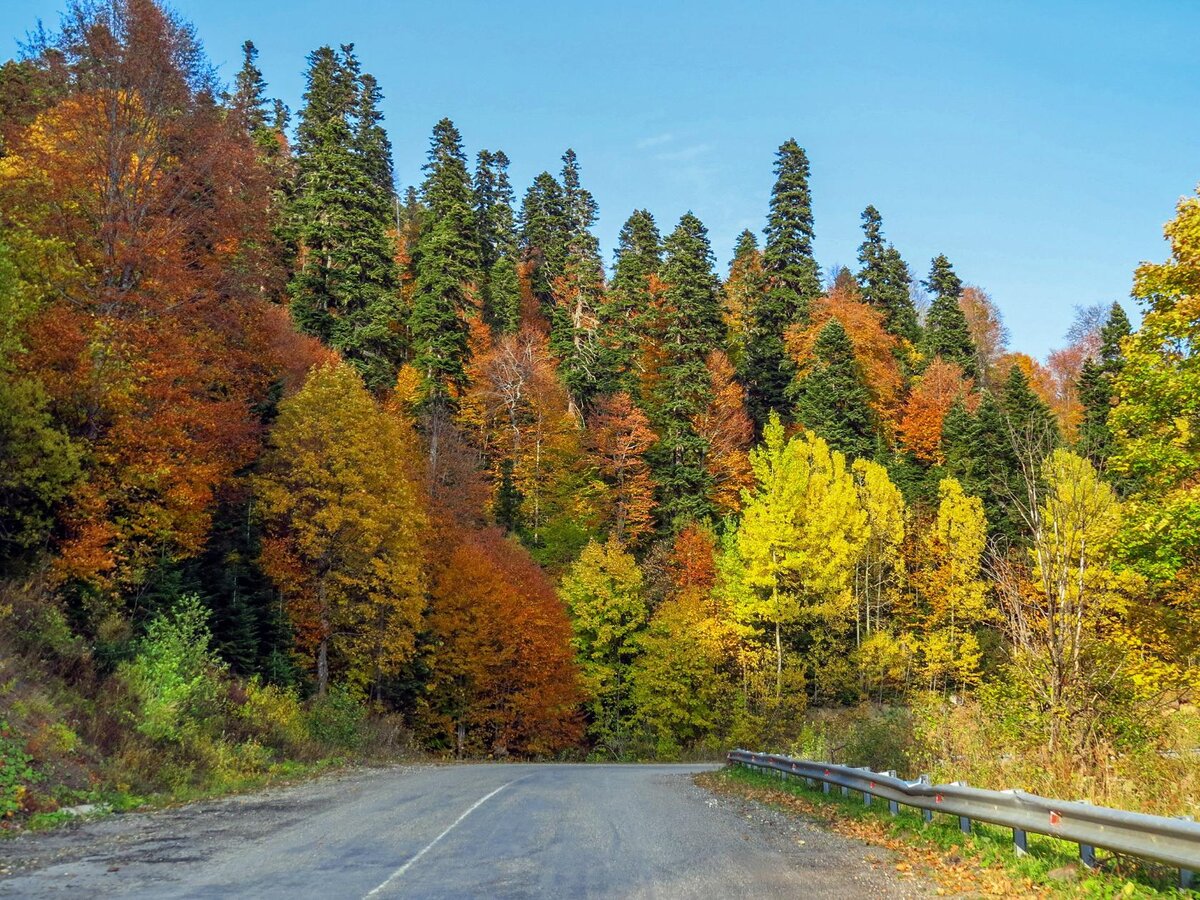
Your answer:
0,0 -> 1200,821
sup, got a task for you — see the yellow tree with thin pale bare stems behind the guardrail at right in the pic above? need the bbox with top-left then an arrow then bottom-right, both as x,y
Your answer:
996,450 -> 1161,751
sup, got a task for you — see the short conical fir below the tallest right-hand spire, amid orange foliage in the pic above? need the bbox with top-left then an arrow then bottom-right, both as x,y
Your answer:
792,319 -> 877,458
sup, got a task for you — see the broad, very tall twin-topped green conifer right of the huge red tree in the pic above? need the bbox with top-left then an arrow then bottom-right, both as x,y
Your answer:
290,46 -> 404,389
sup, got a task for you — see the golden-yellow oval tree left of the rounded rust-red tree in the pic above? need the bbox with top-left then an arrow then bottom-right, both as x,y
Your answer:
254,364 -> 425,694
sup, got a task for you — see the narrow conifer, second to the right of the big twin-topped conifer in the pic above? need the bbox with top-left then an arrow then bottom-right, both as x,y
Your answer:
475,150 -> 521,332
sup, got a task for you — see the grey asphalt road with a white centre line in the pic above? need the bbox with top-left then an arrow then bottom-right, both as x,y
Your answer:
0,764 -> 929,900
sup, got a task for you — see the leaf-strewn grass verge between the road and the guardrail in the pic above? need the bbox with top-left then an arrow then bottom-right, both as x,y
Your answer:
700,767 -> 1200,899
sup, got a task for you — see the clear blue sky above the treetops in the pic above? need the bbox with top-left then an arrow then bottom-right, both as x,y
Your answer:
0,0 -> 1200,356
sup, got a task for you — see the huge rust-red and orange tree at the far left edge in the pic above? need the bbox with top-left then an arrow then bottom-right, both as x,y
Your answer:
0,0 -> 302,595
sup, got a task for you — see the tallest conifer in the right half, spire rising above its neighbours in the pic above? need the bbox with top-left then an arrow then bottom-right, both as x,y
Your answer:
742,140 -> 821,426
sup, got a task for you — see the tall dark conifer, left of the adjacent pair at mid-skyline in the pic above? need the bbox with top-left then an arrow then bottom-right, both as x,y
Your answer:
596,209 -> 662,398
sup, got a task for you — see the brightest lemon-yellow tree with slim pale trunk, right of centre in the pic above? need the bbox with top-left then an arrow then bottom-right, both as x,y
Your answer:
734,414 -> 868,700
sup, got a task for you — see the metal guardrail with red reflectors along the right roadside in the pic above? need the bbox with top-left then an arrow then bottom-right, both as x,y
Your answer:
728,750 -> 1200,888
